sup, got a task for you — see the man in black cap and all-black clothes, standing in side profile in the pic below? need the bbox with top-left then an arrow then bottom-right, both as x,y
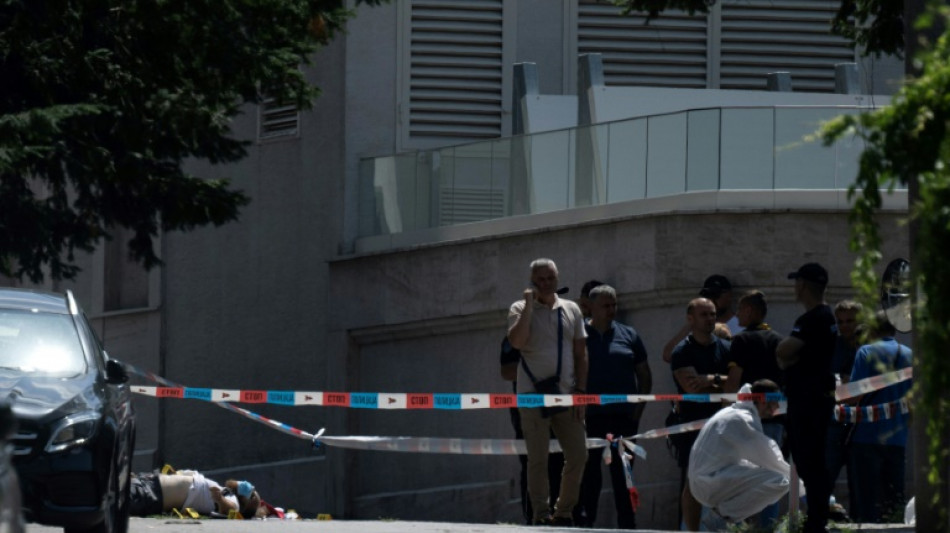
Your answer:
775,263 -> 837,533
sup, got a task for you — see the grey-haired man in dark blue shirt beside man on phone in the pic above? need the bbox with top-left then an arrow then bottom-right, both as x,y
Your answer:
574,285 -> 653,529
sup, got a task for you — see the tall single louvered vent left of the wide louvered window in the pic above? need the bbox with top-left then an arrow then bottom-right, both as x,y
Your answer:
409,0 -> 503,139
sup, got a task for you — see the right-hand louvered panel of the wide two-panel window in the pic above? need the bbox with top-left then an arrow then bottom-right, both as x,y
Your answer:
720,0 -> 854,92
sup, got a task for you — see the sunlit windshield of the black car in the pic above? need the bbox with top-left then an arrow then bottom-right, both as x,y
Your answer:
0,310 -> 86,376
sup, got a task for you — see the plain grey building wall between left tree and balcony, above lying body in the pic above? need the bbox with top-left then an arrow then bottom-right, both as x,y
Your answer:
143,16 -> 358,514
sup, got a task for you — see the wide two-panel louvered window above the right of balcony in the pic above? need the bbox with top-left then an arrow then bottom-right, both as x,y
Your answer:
577,0 -> 855,92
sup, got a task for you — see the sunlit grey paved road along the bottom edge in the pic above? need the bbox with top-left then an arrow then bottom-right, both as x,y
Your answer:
20,518 -> 914,533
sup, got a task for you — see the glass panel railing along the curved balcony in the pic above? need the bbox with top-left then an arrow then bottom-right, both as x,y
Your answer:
360,106 -> 892,237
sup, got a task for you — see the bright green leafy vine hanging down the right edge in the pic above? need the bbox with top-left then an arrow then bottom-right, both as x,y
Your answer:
824,2 -> 950,520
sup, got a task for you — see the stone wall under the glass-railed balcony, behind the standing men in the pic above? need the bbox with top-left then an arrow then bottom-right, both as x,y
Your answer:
328,203 -> 907,529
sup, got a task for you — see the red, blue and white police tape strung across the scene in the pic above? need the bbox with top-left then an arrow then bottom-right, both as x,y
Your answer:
125,364 -> 913,458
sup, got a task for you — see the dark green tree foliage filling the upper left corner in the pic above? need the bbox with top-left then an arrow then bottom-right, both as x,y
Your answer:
0,0 -> 381,281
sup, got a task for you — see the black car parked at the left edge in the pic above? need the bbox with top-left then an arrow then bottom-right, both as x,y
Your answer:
0,288 -> 135,533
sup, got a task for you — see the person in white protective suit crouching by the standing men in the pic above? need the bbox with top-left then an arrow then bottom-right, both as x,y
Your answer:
684,379 -> 790,531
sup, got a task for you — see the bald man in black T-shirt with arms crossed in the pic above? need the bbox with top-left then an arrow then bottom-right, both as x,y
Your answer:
670,298 -> 729,531
